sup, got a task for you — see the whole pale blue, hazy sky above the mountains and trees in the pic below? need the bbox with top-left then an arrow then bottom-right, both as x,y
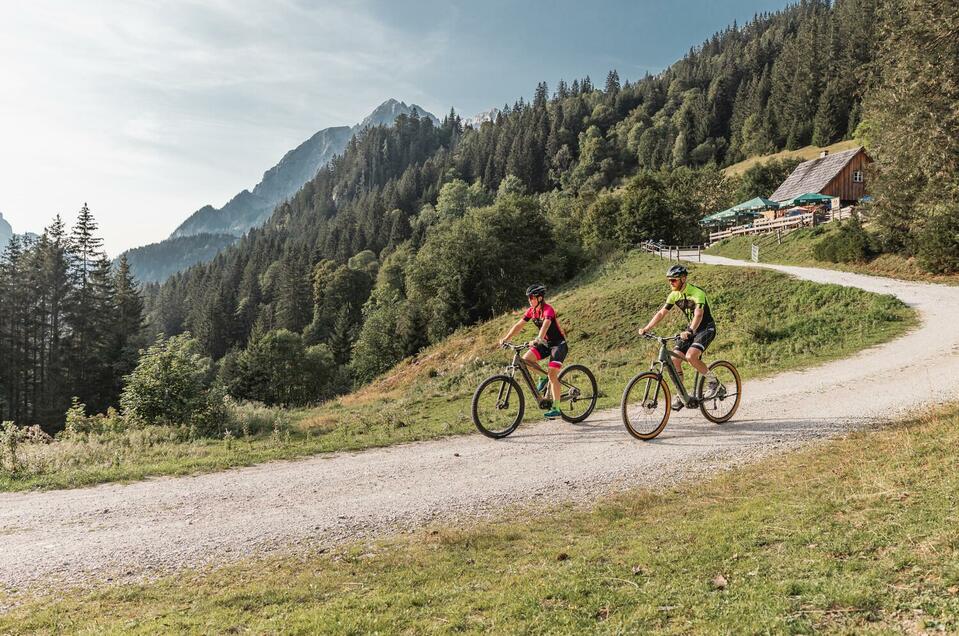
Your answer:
0,0 -> 786,256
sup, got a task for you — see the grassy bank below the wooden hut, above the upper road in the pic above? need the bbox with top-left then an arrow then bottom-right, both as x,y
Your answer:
706,223 -> 959,285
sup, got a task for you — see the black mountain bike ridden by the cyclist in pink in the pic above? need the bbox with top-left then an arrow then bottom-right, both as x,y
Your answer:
471,342 -> 599,439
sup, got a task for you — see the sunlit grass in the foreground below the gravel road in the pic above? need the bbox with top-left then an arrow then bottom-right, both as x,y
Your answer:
9,408 -> 959,634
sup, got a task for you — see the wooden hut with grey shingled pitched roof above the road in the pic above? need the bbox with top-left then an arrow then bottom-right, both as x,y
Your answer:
769,146 -> 872,205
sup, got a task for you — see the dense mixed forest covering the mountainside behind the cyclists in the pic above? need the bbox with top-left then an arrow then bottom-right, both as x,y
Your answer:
5,0 -> 959,430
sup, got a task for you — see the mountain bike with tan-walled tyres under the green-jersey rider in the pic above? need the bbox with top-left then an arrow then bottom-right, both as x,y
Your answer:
621,333 -> 743,440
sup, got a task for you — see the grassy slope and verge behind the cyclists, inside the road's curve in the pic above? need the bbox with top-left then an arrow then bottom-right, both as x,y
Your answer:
0,253 -> 916,490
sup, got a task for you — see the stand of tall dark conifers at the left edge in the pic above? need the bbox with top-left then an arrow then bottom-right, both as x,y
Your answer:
0,205 -> 144,425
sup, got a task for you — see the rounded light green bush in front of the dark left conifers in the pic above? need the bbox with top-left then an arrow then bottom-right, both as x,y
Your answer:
120,333 -> 212,424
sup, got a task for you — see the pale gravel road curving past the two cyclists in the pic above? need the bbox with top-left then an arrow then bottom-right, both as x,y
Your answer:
0,257 -> 959,592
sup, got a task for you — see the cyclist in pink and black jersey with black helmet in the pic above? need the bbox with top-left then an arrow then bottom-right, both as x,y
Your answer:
499,285 -> 569,419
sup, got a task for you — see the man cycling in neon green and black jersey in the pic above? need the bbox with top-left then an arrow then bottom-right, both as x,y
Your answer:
639,264 -> 719,411
